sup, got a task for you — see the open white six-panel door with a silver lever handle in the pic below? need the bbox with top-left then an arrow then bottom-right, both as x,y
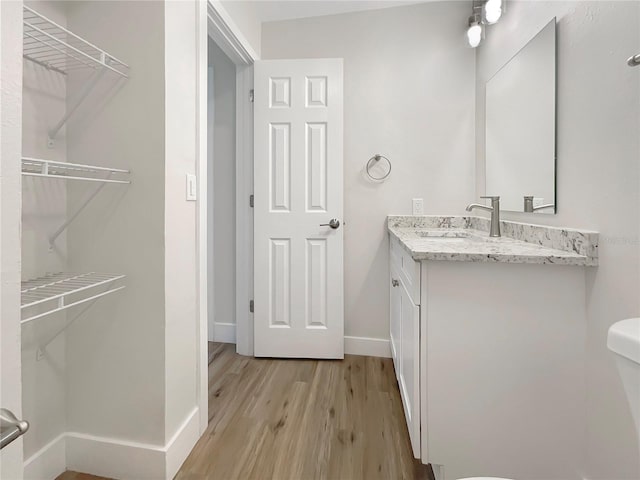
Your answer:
254,59 -> 344,358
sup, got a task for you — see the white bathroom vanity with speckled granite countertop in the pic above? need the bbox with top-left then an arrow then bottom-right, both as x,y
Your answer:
388,216 -> 598,479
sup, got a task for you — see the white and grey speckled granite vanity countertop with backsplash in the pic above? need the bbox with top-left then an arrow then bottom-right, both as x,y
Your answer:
387,216 -> 598,266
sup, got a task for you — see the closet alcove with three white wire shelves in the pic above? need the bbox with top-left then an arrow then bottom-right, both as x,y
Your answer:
21,1 -> 164,478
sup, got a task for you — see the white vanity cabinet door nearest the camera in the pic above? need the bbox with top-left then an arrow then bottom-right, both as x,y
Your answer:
397,282 -> 420,458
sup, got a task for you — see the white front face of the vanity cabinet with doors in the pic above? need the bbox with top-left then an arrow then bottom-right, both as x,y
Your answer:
389,239 -> 420,458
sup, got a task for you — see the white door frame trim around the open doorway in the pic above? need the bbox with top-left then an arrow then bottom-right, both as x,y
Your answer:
196,2 -> 257,432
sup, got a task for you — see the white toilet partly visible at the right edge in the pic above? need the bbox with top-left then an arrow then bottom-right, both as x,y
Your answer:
607,318 -> 640,442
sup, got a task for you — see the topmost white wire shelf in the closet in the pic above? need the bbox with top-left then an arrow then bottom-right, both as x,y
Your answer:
23,6 -> 129,78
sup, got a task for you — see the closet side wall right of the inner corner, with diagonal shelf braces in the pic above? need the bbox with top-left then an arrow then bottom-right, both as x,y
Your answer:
67,1 -> 165,446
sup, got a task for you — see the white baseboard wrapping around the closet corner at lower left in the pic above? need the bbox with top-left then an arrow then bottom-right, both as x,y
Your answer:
24,407 -> 200,480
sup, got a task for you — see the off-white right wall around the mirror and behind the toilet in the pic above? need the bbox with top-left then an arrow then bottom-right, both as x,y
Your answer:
476,1 -> 640,480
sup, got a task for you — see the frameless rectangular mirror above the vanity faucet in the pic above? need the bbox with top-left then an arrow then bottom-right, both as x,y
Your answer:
485,18 -> 556,213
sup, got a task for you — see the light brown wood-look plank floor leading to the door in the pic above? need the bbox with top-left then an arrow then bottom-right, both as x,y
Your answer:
58,344 -> 430,480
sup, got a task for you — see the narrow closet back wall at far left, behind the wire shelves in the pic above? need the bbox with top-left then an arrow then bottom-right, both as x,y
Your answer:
22,1 -> 67,459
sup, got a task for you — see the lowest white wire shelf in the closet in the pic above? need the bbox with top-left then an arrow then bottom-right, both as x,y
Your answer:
20,272 -> 125,325
